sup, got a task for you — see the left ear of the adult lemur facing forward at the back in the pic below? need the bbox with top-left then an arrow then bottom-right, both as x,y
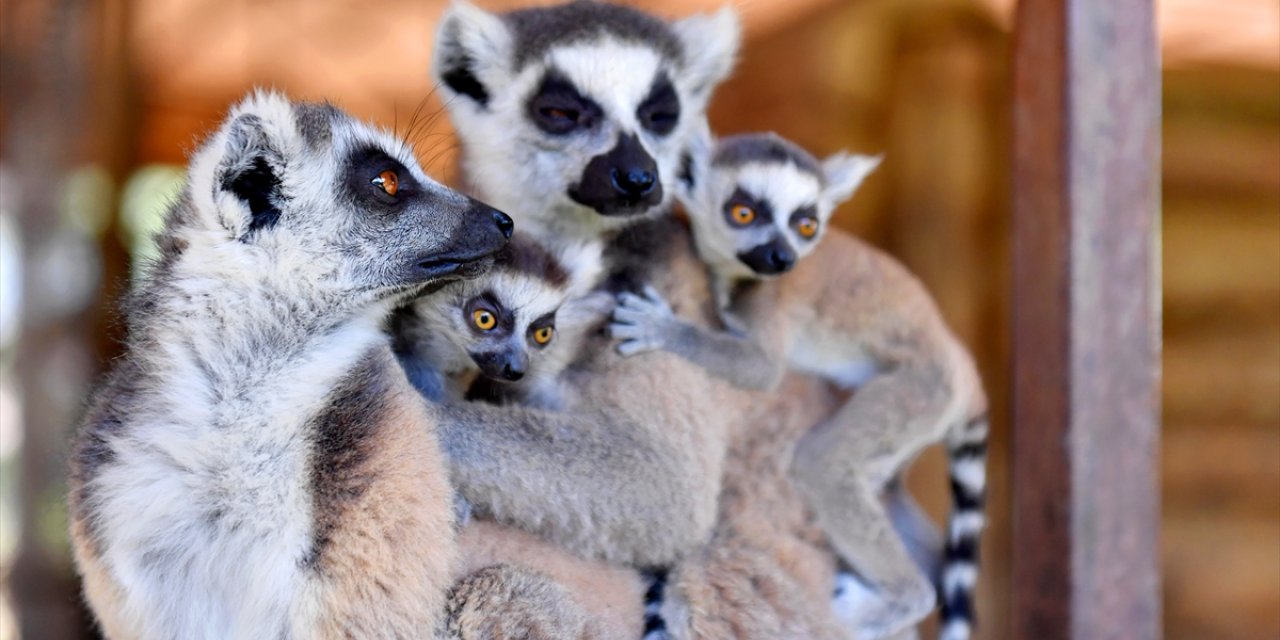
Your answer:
431,0 -> 513,108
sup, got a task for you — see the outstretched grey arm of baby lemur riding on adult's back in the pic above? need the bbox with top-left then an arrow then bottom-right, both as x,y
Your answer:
609,287 -> 786,390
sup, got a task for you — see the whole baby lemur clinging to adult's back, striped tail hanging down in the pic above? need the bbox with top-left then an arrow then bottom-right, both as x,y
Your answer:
611,134 -> 987,639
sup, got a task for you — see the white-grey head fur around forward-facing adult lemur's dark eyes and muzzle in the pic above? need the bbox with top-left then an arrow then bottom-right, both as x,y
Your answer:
433,1 -> 739,242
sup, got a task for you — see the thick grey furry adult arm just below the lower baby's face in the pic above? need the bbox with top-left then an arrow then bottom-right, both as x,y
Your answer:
436,398 -> 719,567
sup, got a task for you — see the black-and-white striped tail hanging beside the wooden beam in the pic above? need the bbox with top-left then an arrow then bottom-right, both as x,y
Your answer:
938,416 -> 988,640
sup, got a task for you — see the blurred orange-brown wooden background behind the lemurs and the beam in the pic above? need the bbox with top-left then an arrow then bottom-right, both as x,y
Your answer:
0,0 -> 1280,639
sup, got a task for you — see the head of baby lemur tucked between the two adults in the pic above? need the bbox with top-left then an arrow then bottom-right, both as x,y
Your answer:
416,234 -> 602,381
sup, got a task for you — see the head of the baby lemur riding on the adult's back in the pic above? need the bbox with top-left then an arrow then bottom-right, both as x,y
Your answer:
680,131 -> 881,279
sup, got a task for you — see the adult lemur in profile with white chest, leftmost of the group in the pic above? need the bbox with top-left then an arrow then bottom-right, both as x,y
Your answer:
70,93 -> 512,637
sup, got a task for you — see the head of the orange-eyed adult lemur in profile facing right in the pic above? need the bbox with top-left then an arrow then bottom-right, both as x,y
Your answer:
175,92 -> 512,308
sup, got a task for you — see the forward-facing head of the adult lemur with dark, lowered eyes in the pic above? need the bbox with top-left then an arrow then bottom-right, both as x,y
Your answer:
433,1 -> 739,236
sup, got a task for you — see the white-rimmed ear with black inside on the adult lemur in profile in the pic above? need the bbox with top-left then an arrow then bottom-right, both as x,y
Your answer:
191,92 -> 298,239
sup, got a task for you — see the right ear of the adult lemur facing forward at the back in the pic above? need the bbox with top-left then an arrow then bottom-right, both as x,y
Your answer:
672,5 -> 742,100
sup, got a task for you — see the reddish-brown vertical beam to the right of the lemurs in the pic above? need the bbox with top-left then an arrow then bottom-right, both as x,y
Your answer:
1012,0 -> 1160,640
